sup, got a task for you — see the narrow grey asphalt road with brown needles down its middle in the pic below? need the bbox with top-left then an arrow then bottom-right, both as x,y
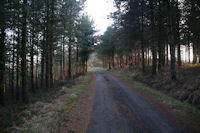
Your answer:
88,72 -> 181,133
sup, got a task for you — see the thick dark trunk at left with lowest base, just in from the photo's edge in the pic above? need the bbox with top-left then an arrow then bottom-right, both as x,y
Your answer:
21,0 -> 28,103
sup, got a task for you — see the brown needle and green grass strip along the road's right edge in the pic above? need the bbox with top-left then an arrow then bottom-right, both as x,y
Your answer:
103,71 -> 200,133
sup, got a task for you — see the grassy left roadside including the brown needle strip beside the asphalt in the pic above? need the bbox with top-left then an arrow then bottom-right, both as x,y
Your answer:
0,73 -> 96,133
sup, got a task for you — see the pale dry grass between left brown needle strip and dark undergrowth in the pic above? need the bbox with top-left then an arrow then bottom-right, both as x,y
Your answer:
3,72 -> 92,133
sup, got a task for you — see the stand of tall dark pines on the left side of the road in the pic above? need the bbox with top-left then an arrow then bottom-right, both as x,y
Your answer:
0,0 -> 95,105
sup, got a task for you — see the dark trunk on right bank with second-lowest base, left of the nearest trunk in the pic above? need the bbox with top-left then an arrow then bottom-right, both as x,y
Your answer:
150,1 -> 157,75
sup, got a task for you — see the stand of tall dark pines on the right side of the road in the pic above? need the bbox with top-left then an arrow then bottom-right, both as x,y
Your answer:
97,0 -> 200,80
